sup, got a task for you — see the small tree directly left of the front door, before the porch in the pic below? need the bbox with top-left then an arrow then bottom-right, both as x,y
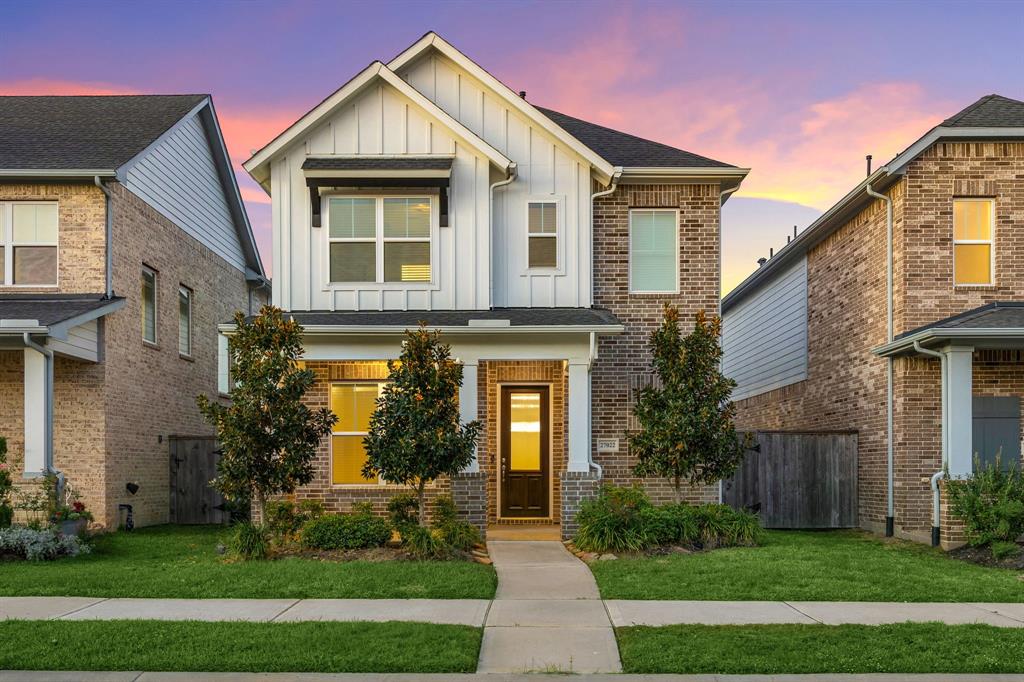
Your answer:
362,325 -> 480,526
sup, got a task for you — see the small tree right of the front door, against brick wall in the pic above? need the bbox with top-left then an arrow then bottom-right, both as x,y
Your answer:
628,304 -> 753,502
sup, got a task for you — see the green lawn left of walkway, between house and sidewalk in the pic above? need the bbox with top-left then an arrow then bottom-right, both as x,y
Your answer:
0,525 -> 497,599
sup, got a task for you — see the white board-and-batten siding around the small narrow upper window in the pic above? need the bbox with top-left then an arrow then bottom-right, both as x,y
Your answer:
398,51 -> 591,307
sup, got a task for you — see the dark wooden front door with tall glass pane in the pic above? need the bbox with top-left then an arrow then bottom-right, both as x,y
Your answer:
501,386 -> 551,518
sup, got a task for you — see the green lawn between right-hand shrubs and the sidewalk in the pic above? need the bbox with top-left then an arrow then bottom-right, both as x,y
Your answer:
590,530 -> 1024,602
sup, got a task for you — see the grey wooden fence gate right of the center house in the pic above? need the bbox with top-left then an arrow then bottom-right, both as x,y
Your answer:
722,431 -> 857,528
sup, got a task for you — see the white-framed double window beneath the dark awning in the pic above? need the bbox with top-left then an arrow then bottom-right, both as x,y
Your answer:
327,197 -> 432,284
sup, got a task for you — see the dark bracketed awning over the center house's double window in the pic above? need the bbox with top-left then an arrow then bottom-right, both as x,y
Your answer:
302,155 -> 455,227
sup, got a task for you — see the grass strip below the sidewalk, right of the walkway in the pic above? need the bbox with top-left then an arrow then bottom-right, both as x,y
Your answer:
616,623 -> 1024,675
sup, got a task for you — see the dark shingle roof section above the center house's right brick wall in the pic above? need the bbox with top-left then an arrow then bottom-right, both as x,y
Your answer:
537,106 -> 735,168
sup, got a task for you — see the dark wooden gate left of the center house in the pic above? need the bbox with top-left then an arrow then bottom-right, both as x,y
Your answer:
169,436 -> 229,523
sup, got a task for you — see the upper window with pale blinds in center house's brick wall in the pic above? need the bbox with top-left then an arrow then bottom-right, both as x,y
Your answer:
630,209 -> 679,294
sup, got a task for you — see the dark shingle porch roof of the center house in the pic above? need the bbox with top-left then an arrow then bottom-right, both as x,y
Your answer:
276,308 -> 622,331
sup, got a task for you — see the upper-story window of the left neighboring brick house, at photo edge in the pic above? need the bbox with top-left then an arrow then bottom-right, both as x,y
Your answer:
0,202 -> 57,287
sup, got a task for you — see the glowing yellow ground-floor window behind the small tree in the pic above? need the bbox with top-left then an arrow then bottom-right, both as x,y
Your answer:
331,383 -> 381,485
